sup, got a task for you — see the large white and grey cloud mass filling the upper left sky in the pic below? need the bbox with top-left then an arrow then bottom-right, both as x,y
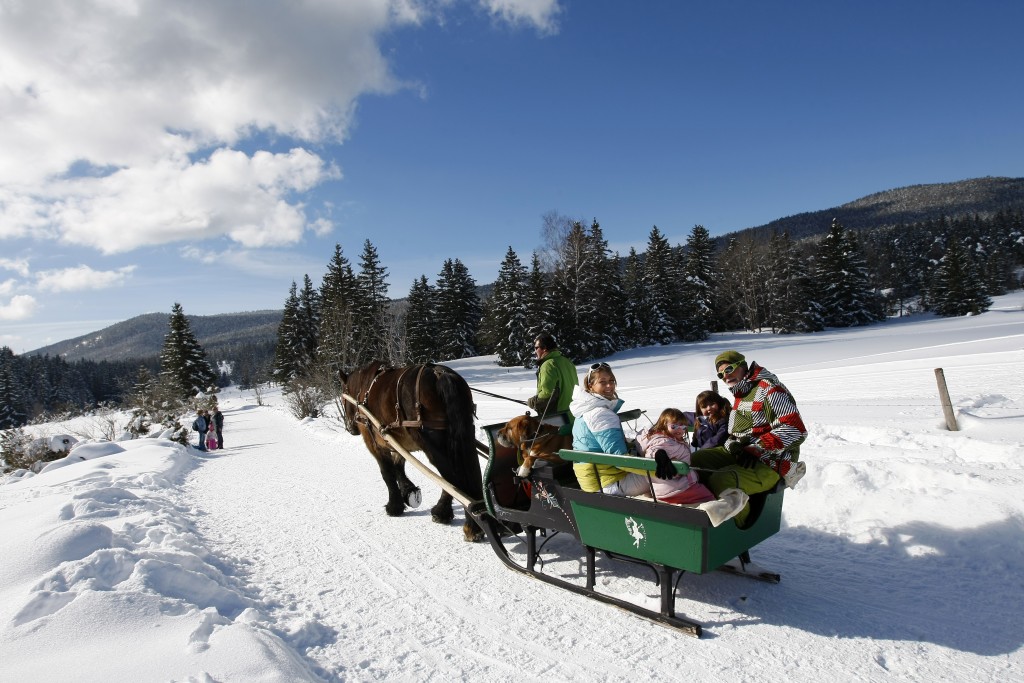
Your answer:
0,0 -> 558,253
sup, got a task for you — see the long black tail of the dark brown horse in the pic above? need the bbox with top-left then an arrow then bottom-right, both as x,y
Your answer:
434,366 -> 483,499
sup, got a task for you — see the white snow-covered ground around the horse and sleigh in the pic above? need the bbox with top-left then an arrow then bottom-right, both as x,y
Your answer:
0,293 -> 1024,682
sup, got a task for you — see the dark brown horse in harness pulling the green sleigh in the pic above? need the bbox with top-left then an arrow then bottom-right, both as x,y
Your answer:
341,360 -> 483,541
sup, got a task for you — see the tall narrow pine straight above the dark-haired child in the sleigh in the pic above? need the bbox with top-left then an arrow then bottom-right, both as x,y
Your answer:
676,225 -> 719,341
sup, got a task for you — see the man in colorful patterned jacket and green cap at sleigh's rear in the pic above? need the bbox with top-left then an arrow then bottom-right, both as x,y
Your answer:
692,350 -> 807,526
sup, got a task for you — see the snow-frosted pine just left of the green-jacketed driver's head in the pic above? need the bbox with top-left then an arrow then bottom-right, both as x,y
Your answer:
484,246 -> 534,368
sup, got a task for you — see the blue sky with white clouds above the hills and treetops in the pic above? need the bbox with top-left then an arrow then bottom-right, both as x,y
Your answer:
0,0 -> 1024,353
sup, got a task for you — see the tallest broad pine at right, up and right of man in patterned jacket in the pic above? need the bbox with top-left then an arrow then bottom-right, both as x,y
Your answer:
813,219 -> 883,328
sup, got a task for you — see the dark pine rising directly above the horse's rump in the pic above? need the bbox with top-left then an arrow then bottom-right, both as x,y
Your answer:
435,259 -> 481,360
